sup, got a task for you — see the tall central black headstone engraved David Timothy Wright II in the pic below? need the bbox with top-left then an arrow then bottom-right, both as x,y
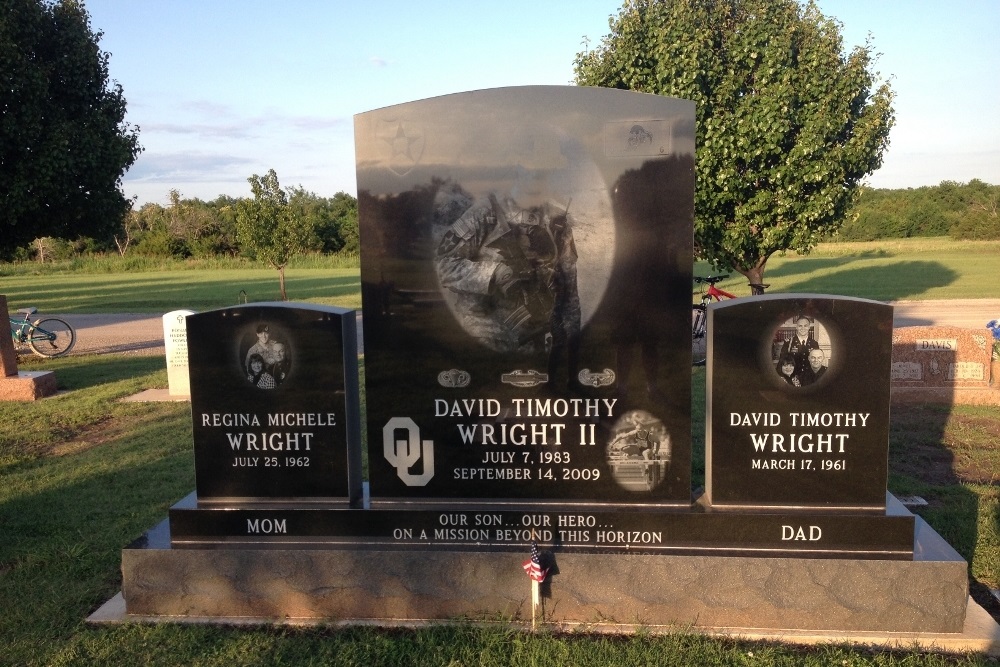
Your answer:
355,87 -> 694,506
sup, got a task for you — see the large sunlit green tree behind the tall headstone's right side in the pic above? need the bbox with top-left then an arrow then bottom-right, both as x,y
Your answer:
574,0 -> 894,285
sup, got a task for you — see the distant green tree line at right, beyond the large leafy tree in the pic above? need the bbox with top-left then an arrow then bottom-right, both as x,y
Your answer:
837,179 -> 1000,241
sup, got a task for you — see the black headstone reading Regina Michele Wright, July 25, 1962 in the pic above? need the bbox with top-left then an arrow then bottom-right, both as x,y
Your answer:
187,303 -> 361,504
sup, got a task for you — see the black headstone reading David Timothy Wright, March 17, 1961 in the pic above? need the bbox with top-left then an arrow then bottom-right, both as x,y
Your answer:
705,294 -> 892,512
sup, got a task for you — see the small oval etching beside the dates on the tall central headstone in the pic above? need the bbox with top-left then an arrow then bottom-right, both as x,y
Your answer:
607,410 -> 670,491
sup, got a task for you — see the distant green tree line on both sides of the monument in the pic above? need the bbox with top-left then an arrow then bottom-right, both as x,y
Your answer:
10,179 -> 1000,262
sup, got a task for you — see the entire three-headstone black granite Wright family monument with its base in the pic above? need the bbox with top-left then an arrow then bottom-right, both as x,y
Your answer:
111,87 -> 967,632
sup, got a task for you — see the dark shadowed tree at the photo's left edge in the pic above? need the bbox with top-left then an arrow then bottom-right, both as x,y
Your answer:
0,0 -> 141,254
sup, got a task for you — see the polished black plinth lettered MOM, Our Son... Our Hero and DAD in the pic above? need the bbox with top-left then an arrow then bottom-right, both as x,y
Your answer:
170,494 -> 914,560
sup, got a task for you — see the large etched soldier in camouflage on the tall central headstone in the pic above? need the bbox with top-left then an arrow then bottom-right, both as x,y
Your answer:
435,187 -> 580,368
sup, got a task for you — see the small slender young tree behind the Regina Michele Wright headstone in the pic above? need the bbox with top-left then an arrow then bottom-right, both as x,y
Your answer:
236,169 -> 314,301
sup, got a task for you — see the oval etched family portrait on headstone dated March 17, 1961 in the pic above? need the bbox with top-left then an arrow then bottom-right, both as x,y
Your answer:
771,314 -> 831,387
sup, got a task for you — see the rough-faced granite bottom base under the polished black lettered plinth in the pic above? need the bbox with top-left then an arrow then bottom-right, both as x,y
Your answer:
122,518 -> 968,633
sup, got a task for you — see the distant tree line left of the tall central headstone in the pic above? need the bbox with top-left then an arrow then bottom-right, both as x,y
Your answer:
10,186 -> 360,262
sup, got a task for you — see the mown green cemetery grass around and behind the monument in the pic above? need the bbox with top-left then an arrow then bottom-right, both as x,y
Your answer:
0,240 -> 1000,667
